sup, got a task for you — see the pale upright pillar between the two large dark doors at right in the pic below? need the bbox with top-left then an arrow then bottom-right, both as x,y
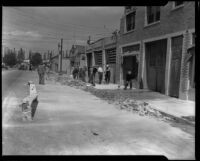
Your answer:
165,37 -> 172,95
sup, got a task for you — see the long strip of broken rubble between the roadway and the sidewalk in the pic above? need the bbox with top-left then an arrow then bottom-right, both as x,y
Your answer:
47,74 -> 193,123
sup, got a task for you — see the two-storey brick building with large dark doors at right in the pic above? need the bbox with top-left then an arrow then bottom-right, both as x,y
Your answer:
117,1 -> 195,100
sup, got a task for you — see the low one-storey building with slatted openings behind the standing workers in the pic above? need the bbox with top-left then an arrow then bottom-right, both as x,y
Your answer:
86,35 -> 117,83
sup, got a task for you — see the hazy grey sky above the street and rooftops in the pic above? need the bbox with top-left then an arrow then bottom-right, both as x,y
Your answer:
2,7 -> 124,57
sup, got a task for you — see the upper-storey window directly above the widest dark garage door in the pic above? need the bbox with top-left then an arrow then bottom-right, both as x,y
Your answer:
147,6 -> 160,24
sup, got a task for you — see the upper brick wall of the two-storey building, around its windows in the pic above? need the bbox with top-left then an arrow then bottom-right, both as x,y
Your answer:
119,1 -> 195,45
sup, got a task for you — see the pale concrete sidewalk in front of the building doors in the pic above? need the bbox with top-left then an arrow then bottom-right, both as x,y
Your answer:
94,84 -> 195,122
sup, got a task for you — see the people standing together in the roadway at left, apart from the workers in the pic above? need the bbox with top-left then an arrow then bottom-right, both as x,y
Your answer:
37,63 -> 50,84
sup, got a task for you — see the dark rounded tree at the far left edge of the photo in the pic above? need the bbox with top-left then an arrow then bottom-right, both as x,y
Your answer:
3,51 -> 17,67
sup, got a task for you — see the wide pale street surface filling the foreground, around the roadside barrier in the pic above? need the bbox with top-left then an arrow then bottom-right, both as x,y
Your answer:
2,70 -> 195,159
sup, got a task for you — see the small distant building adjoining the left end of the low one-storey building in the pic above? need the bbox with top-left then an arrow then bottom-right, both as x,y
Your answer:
70,45 -> 86,68
